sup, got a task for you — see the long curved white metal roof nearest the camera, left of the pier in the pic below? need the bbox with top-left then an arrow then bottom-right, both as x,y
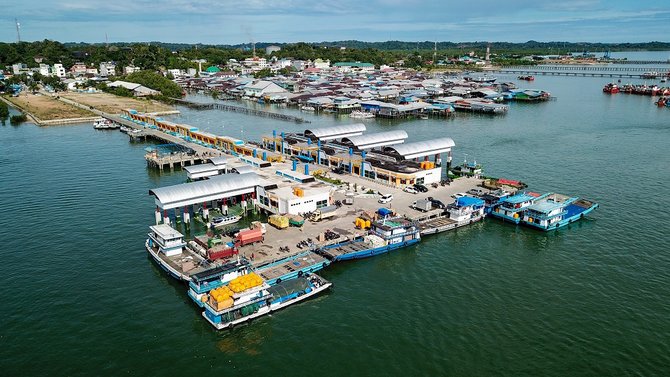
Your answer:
149,173 -> 263,209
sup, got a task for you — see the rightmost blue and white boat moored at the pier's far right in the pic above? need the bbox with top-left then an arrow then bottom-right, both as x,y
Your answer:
521,194 -> 598,231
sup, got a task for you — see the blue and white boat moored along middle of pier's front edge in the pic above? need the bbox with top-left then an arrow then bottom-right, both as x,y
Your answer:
316,217 -> 421,262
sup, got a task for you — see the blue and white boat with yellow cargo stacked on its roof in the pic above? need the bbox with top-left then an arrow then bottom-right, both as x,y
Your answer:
202,273 -> 333,330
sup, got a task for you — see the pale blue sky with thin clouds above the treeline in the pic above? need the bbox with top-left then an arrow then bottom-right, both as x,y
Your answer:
0,0 -> 670,44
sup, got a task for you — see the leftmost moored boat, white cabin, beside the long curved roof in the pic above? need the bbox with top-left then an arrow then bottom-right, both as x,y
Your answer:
145,224 -> 211,281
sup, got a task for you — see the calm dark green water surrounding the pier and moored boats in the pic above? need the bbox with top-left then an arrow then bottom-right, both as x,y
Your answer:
0,61 -> 670,376
